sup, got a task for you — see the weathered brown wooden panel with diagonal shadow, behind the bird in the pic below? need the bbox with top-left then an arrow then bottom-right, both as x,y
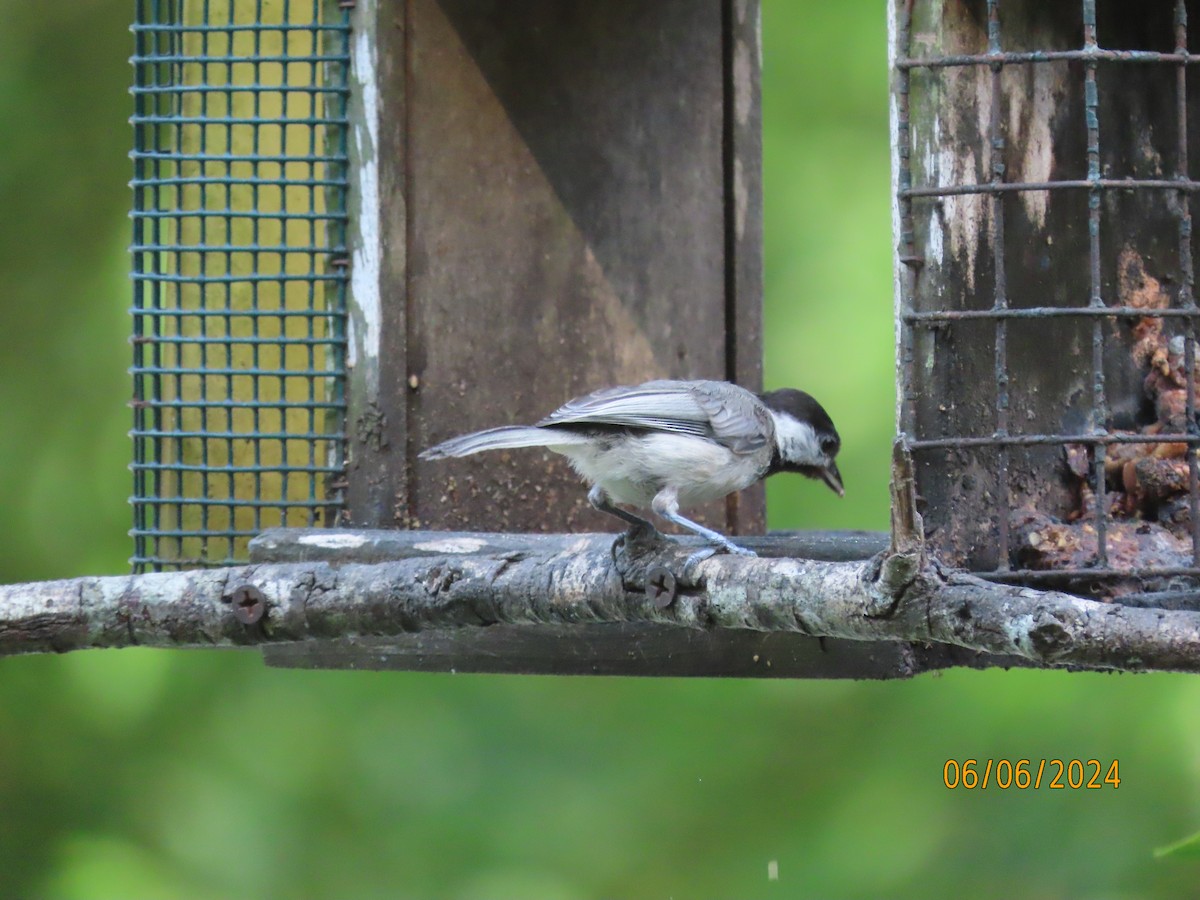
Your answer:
347,0 -> 763,534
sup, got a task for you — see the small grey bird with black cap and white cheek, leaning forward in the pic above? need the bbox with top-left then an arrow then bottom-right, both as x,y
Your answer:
420,380 -> 845,557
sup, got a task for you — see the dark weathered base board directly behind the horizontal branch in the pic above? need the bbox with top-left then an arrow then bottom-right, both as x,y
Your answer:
251,528 -> 974,678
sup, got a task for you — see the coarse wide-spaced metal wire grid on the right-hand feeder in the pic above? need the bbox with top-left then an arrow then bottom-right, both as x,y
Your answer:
893,0 -> 1200,583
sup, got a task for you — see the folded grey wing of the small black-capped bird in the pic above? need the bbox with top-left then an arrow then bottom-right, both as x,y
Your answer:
538,380 -> 772,454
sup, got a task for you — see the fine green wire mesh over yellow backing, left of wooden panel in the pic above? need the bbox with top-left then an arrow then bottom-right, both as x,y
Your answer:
131,0 -> 349,571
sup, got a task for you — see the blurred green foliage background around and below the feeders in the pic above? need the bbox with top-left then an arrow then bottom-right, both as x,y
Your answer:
0,0 -> 1200,900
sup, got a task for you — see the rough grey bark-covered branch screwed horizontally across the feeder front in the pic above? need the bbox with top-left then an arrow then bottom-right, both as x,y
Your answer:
0,530 -> 1200,672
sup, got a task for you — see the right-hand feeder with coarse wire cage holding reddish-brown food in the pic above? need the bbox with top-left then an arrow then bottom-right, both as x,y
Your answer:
892,0 -> 1200,596
